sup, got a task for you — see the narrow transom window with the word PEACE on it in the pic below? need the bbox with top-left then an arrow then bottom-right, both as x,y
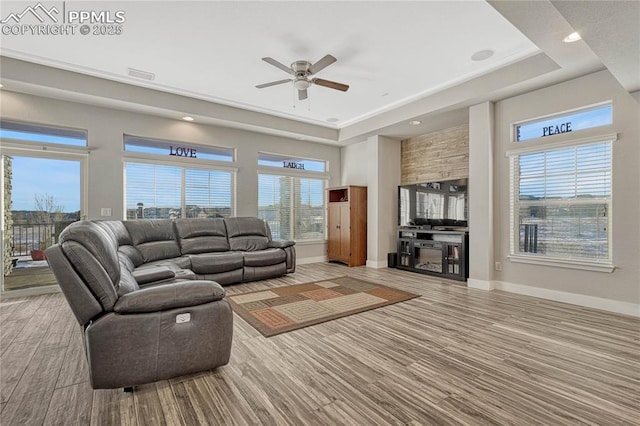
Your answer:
514,104 -> 613,142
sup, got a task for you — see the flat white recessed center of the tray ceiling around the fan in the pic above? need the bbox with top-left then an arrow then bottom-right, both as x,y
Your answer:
2,1 -> 538,127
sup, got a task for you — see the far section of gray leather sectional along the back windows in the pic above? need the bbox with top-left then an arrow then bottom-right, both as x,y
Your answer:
104,217 -> 296,285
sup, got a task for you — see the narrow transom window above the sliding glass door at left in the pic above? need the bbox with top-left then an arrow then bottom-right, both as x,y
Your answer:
0,120 -> 87,147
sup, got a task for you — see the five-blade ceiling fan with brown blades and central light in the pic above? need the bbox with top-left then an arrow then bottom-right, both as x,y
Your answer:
256,55 -> 349,101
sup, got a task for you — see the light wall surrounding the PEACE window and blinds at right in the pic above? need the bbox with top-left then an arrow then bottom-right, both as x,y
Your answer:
490,71 -> 640,315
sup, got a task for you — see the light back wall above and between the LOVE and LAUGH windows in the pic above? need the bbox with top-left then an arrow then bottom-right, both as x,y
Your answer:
0,90 -> 340,263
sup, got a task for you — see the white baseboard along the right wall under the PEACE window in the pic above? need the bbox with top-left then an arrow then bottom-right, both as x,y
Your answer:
490,279 -> 640,317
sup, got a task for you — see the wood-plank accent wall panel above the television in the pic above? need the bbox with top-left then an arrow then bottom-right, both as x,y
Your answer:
400,124 -> 469,185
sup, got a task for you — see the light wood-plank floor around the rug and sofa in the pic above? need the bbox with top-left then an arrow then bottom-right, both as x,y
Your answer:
0,264 -> 640,426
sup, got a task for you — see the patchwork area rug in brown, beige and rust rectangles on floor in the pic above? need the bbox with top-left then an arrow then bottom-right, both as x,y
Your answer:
227,277 -> 418,337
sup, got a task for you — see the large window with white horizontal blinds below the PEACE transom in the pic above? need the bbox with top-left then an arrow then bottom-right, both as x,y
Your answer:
509,137 -> 615,265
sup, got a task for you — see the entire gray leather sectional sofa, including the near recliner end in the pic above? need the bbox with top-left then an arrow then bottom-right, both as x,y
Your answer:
46,217 -> 295,389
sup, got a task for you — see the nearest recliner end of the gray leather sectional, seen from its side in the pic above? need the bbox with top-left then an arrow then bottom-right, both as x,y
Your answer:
46,221 -> 233,389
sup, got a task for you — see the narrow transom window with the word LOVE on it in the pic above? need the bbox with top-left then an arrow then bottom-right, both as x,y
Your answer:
124,135 -> 234,161
